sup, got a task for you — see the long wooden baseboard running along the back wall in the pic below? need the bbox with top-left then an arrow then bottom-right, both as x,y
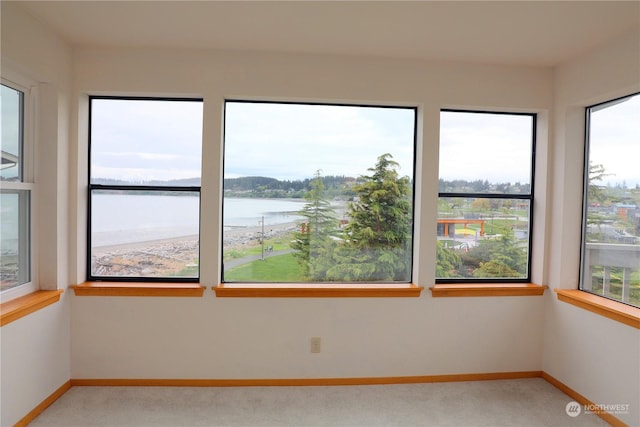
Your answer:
71,371 -> 542,387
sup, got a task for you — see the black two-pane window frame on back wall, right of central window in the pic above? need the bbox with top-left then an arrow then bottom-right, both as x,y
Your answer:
434,108 -> 538,289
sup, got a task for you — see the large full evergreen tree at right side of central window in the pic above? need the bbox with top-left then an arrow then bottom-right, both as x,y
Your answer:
326,153 -> 412,281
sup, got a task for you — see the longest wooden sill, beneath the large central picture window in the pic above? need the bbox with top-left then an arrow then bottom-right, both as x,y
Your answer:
212,283 -> 424,298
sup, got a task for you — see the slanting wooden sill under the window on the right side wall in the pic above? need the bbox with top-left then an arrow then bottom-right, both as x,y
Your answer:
554,289 -> 640,329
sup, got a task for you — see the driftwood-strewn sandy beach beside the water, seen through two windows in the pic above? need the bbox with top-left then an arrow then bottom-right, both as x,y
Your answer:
91,222 -> 297,277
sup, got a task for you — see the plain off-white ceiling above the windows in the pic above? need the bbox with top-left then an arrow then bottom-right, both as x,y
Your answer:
13,1 -> 640,67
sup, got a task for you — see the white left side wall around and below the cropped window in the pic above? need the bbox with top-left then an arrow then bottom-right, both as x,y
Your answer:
0,2 -> 71,426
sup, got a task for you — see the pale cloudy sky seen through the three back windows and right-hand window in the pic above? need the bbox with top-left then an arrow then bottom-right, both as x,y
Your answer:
84,96 -> 640,185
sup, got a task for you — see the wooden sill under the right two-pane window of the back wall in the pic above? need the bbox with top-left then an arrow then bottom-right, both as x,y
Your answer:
429,283 -> 547,298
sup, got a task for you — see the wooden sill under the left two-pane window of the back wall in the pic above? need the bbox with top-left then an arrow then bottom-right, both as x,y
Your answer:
71,282 -> 205,297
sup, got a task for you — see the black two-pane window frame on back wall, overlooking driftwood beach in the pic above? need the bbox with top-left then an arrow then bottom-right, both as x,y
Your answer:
85,95 -> 204,284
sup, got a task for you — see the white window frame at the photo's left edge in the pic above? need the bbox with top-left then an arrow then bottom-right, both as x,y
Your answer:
0,77 -> 39,301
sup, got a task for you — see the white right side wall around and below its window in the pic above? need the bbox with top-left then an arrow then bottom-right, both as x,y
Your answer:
543,30 -> 640,425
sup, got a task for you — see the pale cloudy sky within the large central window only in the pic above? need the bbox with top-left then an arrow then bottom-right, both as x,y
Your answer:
224,102 -> 415,180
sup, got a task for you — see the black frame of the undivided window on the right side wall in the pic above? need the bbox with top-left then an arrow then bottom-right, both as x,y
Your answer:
578,92 -> 640,308
